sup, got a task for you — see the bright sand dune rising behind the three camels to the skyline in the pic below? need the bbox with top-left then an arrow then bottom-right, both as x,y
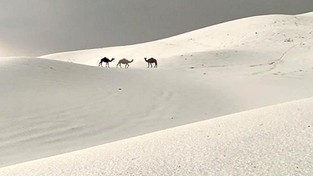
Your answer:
42,13 -> 313,74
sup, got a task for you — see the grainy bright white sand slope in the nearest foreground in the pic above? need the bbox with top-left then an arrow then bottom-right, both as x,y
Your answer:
0,98 -> 313,176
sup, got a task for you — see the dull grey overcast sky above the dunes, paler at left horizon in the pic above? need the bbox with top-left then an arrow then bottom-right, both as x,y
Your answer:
0,0 -> 313,57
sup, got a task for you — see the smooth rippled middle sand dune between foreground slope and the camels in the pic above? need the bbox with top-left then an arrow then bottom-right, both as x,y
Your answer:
0,58 -> 313,166
